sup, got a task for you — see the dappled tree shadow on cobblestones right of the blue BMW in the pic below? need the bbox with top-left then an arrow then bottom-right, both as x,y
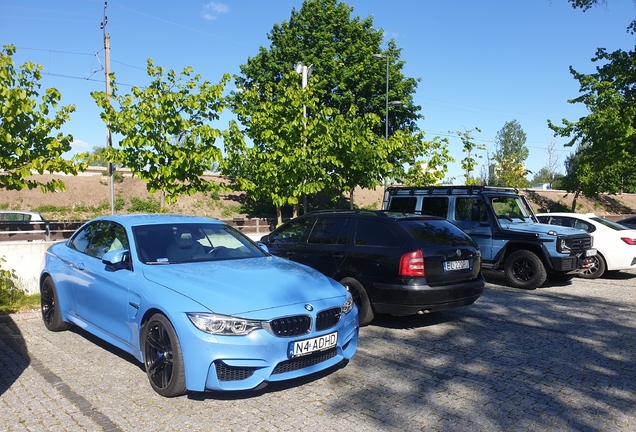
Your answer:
328,273 -> 636,430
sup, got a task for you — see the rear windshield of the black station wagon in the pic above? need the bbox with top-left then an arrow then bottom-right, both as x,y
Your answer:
398,219 -> 474,246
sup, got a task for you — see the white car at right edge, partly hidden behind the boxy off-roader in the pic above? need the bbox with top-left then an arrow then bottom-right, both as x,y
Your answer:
537,213 -> 636,279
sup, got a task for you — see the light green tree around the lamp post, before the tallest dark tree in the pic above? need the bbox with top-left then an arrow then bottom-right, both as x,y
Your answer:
221,74 -> 326,223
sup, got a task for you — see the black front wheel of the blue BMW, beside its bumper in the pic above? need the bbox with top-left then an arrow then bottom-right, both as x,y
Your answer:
141,314 -> 186,397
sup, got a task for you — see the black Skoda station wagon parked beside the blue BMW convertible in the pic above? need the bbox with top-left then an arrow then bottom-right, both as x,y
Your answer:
261,210 -> 484,325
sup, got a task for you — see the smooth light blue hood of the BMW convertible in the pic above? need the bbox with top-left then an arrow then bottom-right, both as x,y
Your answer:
142,257 -> 345,315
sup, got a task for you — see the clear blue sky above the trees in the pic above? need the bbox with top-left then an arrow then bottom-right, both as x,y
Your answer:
0,0 -> 636,182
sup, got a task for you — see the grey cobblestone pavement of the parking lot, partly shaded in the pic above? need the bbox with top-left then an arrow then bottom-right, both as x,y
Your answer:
0,271 -> 636,431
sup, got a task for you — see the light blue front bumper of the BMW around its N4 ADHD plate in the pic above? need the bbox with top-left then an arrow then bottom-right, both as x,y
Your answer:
175,307 -> 358,391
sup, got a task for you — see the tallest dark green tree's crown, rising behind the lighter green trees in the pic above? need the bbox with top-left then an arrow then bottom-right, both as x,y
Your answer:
233,0 -> 420,136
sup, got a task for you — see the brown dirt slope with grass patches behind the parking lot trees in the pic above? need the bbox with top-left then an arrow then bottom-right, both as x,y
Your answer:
0,170 -> 636,220
